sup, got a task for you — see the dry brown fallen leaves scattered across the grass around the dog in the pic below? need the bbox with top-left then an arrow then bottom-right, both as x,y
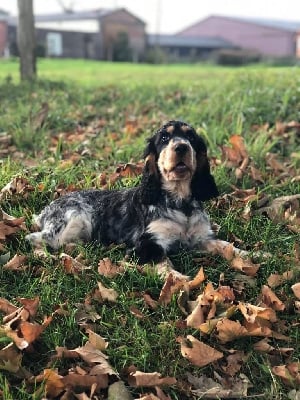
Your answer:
0,123 -> 300,400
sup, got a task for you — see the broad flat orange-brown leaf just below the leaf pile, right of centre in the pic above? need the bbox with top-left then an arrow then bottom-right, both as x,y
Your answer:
179,335 -> 223,367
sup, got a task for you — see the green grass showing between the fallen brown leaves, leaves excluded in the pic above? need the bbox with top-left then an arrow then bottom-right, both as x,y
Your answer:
0,60 -> 300,400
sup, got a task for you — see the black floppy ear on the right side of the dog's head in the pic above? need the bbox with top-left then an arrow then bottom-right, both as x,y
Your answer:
191,152 -> 219,201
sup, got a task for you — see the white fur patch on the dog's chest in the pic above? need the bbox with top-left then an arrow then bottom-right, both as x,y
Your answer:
147,209 -> 212,249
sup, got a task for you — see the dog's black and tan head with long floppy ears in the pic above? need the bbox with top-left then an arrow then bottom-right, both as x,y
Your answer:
144,121 -> 218,202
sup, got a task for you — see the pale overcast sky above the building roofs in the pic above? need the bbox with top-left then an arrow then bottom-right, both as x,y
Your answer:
0,0 -> 300,33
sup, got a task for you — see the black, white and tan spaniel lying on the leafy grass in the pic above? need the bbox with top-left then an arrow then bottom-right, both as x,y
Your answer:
26,120 -> 247,272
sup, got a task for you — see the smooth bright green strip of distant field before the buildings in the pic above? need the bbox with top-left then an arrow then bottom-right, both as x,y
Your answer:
0,59 -> 300,85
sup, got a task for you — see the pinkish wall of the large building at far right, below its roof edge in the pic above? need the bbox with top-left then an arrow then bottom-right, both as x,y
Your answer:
178,16 -> 296,57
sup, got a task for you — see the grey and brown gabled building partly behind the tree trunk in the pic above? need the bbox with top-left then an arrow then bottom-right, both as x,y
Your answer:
7,8 -> 146,61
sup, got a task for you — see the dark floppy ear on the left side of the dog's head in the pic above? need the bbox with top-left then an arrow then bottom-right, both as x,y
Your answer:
141,138 -> 161,205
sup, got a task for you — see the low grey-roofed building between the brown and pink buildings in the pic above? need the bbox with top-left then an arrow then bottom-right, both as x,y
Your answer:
147,34 -> 235,61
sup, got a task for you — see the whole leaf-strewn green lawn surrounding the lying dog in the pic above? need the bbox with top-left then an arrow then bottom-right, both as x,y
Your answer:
0,60 -> 300,400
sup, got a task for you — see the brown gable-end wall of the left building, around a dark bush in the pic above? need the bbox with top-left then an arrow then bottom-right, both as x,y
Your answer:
100,10 -> 146,61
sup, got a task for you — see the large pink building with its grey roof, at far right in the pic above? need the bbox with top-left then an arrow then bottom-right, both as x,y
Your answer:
177,15 -> 300,58
